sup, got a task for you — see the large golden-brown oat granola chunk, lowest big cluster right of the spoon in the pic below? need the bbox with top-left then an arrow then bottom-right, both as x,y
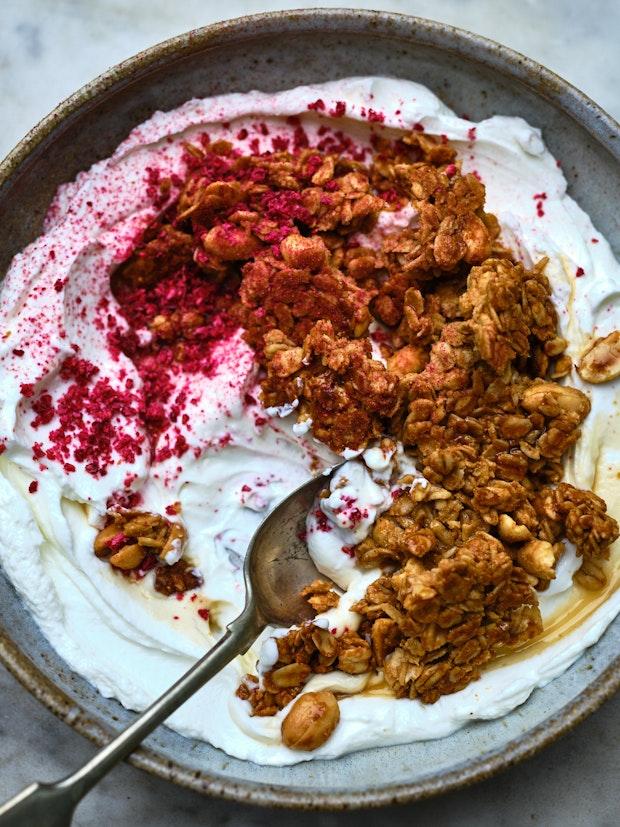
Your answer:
354,532 -> 542,703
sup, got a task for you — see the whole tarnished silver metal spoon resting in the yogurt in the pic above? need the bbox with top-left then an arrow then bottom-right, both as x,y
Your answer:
0,469 -> 335,827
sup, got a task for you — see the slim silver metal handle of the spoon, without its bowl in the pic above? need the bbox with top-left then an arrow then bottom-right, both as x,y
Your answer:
0,601 -> 265,827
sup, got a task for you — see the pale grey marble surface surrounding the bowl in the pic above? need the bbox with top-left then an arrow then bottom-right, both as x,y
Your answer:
0,0 -> 620,827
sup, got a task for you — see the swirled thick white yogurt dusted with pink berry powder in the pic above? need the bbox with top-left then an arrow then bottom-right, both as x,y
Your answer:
0,78 -> 620,764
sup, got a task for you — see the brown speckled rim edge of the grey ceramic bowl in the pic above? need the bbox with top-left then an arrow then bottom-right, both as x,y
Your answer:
0,9 -> 620,809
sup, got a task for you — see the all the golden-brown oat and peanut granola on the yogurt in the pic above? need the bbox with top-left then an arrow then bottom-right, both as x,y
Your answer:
46,105 -> 618,750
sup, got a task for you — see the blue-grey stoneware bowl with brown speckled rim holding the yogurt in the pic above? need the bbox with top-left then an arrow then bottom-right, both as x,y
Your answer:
0,9 -> 620,808
